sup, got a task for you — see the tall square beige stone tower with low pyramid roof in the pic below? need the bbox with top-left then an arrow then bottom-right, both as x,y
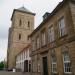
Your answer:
7,7 -> 35,69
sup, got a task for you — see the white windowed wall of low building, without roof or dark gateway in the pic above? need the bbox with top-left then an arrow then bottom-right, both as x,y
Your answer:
16,48 -> 31,71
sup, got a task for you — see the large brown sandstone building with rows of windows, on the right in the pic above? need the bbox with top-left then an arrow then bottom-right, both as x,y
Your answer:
30,0 -> 75,75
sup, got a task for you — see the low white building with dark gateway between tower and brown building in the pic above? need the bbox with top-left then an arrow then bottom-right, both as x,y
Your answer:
16,45 -> 31,72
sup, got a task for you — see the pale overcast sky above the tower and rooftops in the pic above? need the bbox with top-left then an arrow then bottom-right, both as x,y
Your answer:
0,0 -> 62,61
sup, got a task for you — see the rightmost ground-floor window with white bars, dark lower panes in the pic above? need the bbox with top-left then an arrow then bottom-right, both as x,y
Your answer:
63,52 -> 71,73
